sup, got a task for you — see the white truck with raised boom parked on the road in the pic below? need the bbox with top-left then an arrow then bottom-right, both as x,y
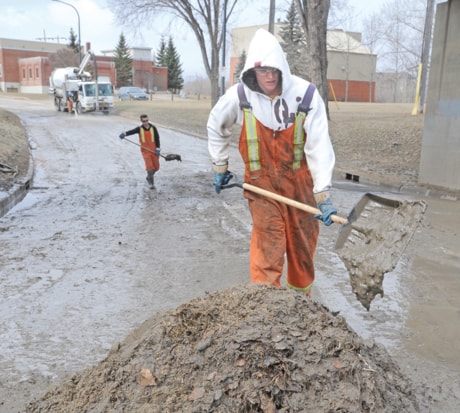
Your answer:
49,50 -> 113,114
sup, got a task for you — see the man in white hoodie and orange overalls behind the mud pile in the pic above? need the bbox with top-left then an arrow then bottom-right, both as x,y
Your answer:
207,29 -> 337,295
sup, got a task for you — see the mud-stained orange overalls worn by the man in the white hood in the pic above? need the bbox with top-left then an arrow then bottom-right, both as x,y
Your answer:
239,90 -> 319,295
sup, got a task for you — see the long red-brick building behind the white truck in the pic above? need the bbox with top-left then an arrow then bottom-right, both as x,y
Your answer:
0,38 -> 168,93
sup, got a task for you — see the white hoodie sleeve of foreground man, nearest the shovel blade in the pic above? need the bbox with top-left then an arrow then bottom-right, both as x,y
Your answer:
304,91 -> 335,194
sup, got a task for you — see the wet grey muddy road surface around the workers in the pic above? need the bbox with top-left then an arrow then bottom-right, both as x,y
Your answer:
0,100 -> 460,413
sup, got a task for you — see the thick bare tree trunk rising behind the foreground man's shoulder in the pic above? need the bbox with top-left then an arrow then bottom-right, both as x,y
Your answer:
296,0 -> 330,117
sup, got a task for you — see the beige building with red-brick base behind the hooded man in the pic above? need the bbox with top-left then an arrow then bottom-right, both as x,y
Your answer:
229,24 -> 377,102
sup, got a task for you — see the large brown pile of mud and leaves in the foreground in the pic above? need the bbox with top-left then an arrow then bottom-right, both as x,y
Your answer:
27,284 -> 418,413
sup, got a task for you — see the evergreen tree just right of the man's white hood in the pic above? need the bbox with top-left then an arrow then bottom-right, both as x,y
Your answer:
280,0 -> 307,78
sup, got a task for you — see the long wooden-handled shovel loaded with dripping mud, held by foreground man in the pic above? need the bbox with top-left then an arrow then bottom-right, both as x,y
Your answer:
222,172 -> 427,311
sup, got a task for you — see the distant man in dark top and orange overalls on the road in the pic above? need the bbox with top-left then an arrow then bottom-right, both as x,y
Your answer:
120,114 -> 160,189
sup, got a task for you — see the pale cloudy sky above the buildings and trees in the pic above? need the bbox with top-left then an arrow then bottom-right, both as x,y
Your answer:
0,0 -> 404,78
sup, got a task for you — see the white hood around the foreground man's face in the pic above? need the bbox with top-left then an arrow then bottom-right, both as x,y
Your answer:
240,29 -> 291,92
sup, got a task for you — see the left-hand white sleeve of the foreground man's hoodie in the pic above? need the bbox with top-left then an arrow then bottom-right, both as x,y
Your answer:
207,86 -> 239,166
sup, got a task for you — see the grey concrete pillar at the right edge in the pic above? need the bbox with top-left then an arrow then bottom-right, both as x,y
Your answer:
419,0 -> 460,191
